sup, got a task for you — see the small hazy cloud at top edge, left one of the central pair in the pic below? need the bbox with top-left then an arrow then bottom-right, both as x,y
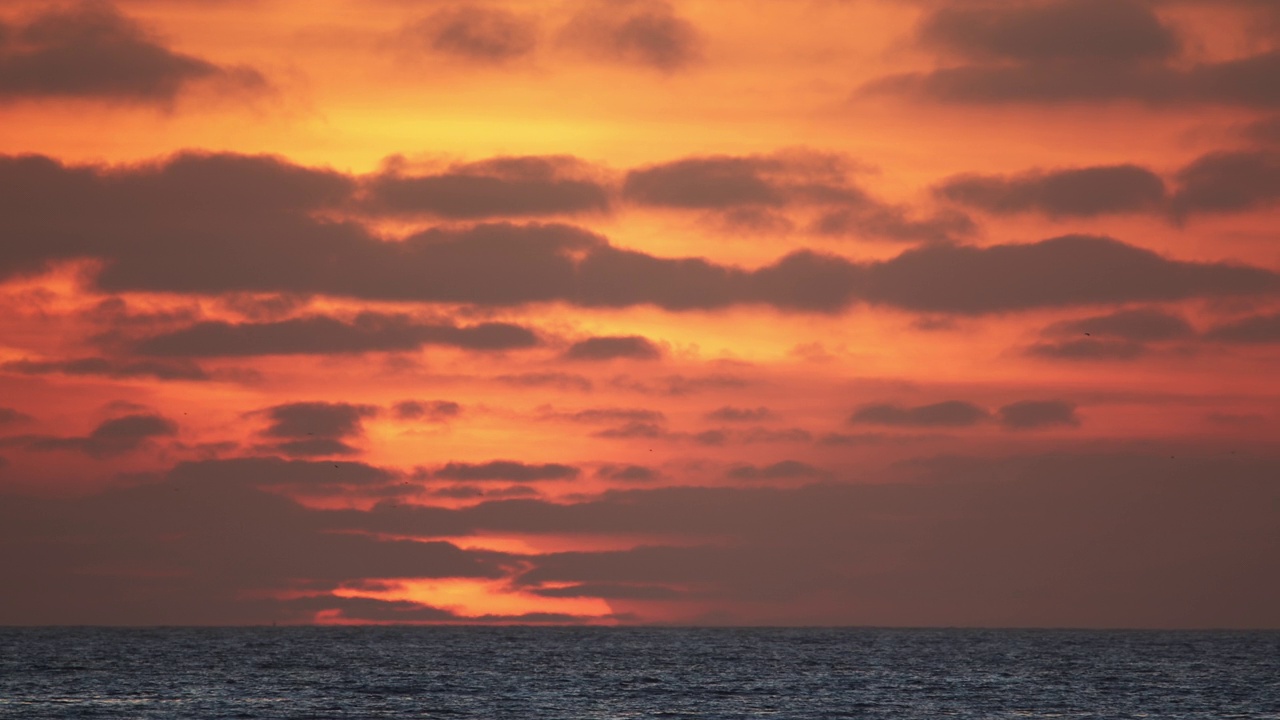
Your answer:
401,5 -> 538,63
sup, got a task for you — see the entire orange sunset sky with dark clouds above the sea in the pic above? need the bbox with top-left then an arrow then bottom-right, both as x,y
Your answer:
0,0 -> 1280,628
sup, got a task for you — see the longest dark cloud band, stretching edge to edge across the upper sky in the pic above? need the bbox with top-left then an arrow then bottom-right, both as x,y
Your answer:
0,155 -> 1280,313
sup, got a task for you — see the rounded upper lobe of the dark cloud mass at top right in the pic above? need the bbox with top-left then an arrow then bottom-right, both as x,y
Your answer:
918,0 -> 1179,63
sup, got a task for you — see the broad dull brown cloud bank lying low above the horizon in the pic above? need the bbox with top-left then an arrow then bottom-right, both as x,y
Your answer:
0,451 -> 1280,628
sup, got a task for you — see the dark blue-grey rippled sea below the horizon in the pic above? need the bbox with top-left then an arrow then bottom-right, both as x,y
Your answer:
0,626 -> 1280,720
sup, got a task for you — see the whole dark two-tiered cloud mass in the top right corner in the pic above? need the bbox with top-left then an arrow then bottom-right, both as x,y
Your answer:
863,0 -> 1280,108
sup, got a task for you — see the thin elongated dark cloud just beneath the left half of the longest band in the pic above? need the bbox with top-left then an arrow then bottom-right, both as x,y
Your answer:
134,313 -> 539,357
